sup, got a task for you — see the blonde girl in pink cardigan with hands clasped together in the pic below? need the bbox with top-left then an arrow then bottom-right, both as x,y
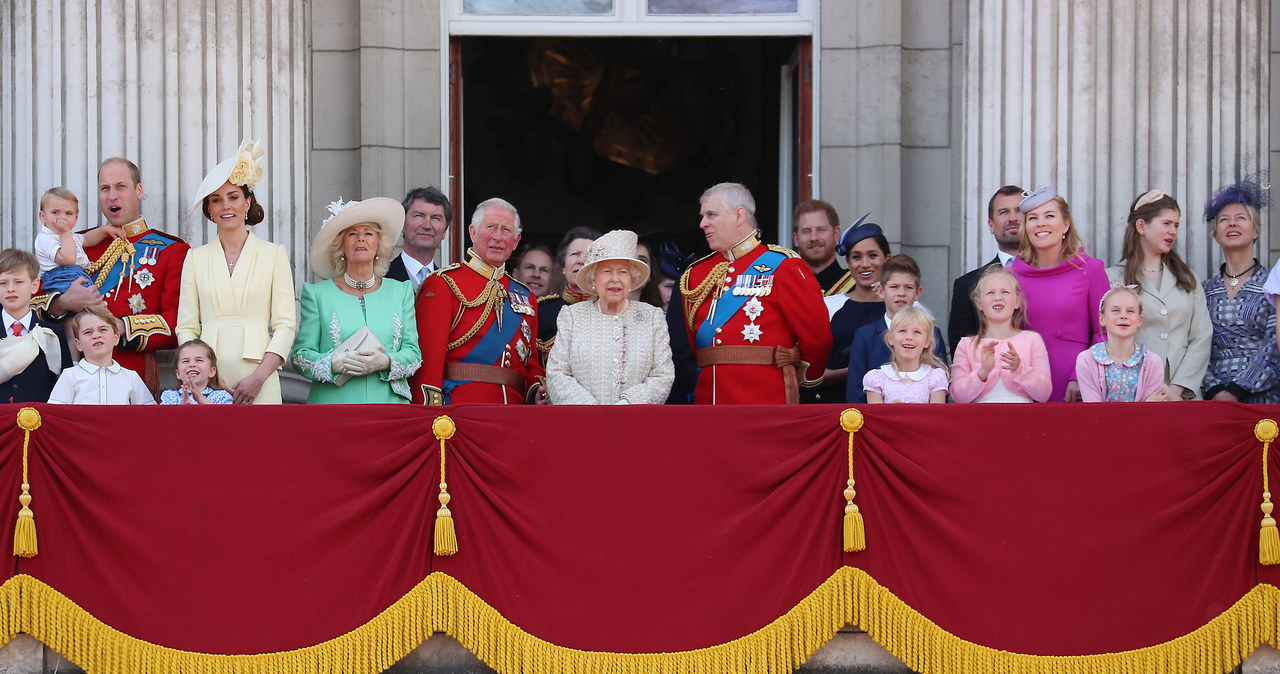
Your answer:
951,266 -> 1053,403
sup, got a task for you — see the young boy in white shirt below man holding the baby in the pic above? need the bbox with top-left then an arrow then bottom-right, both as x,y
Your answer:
49,304 -> 156,405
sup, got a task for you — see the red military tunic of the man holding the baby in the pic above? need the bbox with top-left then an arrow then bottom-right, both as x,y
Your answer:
84,220 -> 191,386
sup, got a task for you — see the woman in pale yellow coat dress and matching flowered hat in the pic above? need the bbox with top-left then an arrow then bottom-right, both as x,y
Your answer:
178,141 -> 297,404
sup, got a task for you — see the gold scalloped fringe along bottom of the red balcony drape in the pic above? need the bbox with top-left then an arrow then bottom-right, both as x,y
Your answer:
0,567 -> 1280,674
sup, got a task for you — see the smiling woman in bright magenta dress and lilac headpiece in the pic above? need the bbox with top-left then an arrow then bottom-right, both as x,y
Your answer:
1009,185 -> 1111,403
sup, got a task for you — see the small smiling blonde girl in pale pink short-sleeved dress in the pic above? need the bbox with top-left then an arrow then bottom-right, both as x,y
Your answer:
863,307 -> 947,403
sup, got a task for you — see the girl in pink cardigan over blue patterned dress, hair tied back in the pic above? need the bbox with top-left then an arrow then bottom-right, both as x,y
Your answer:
1075,285 -> 1170,403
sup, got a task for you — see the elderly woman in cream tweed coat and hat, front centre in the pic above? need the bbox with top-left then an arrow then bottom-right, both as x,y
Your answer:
547,230 -> 676,405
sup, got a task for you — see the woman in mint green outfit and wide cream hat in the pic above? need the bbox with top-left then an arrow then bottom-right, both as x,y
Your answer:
291,197 -> 422,403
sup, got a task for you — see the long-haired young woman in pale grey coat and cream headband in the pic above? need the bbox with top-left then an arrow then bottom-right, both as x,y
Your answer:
1107,189 -> 1213,400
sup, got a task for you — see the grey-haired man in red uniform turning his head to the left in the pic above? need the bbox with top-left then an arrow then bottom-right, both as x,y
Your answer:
680,183 -> 831,404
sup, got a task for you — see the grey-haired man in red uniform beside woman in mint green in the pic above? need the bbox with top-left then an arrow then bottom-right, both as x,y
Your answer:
410,198 -> 545,404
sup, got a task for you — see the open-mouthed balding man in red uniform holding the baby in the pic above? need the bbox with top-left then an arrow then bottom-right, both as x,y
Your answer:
32,157 -> 191,393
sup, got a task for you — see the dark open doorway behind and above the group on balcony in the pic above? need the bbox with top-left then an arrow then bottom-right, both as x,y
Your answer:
451,37 -> 810,260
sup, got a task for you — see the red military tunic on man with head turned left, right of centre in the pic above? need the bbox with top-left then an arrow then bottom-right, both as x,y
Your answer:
680,231 -> 831,404
